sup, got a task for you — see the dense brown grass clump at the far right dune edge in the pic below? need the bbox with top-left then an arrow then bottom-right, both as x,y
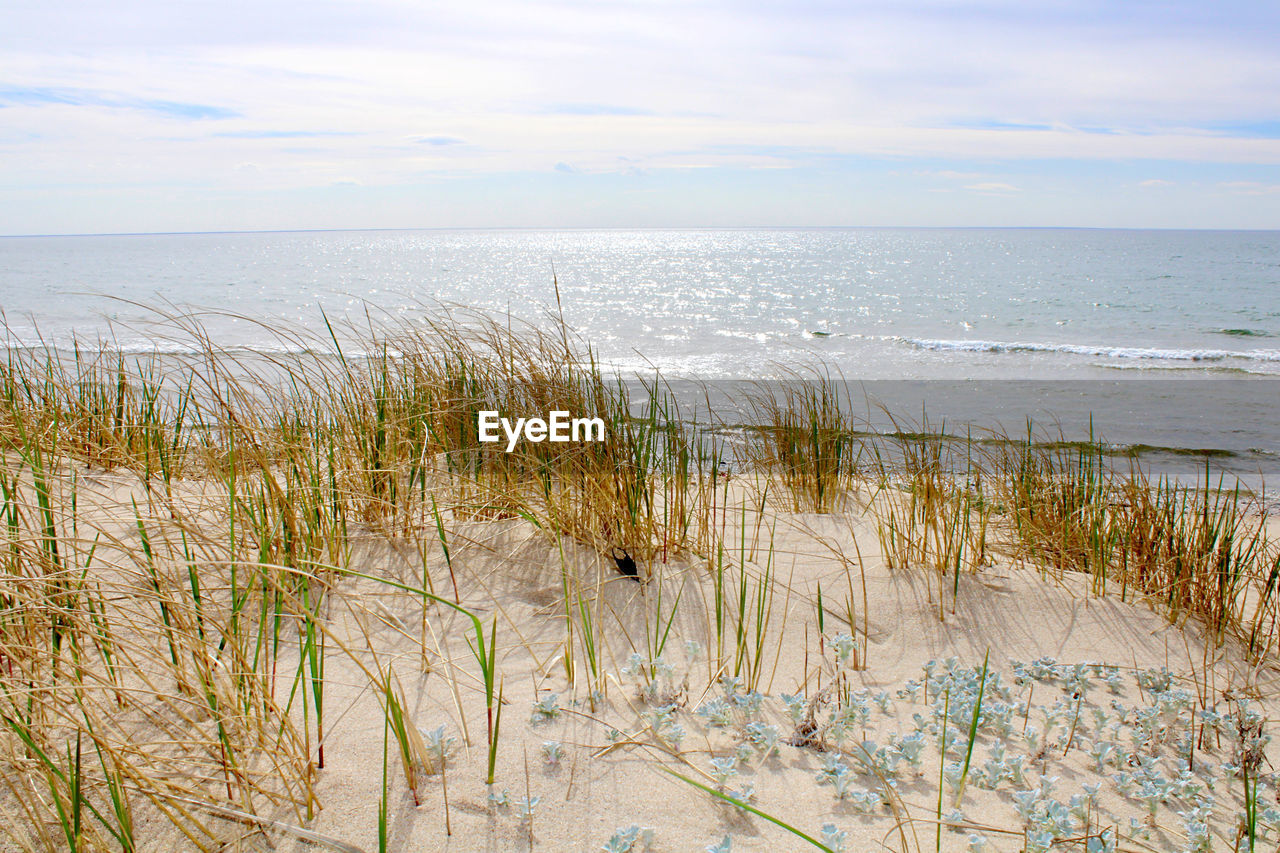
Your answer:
988,428 -> 1280,653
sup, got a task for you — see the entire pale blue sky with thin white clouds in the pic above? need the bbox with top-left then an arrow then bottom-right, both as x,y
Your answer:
0,0 -> 1280,234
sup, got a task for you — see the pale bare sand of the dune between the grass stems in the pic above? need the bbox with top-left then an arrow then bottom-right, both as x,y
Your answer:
57,473 -> 1259,853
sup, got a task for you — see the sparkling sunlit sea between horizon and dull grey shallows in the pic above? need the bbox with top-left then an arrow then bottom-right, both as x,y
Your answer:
0,229 -> 1280,379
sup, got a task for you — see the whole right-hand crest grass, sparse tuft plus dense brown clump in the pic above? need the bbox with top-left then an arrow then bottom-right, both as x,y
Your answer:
863,409 -> 1280,656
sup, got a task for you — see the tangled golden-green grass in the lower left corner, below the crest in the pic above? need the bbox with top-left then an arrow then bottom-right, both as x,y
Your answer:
0,448 -> 314,849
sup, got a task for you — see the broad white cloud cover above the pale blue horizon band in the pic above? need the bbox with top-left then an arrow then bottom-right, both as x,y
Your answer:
0,0 -> 1280,229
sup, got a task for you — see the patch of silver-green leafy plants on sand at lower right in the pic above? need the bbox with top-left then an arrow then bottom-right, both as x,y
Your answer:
890,658 -> 1280,853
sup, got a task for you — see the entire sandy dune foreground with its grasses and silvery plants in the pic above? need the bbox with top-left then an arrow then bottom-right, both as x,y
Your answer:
0,311 -> 1280,852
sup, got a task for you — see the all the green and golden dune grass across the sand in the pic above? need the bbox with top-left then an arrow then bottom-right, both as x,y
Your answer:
0,302 -> 1280,850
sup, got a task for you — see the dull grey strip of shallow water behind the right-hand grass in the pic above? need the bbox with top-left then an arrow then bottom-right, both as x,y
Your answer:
645,379 -> 1280,492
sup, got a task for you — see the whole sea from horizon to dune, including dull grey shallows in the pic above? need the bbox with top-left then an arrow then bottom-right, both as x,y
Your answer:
0,228 -> 1280,485
